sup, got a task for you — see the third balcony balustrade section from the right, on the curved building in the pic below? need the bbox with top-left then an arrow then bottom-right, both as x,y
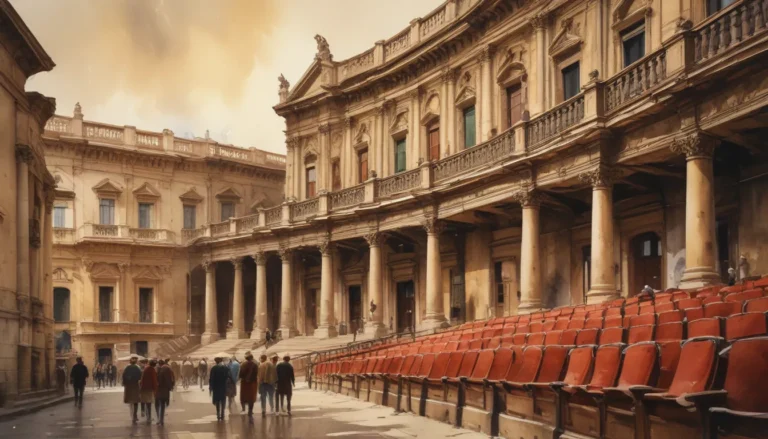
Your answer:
526,93 -> 584,151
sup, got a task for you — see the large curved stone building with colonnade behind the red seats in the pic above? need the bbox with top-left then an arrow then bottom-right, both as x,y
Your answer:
177,0 -> 768,340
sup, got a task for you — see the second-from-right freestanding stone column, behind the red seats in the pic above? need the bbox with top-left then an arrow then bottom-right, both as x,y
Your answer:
579,166 -> 618,304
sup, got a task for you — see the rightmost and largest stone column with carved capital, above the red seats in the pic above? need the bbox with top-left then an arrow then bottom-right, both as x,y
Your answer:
671,133 -> 720,288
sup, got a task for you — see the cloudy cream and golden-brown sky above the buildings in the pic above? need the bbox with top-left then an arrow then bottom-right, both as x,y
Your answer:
11,0 -> 442,153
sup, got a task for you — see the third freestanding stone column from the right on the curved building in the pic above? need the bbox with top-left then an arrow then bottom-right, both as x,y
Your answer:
515,188 -> 541,314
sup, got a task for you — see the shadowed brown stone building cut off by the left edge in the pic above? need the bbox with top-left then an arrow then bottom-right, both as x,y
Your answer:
0,0 -> 56,406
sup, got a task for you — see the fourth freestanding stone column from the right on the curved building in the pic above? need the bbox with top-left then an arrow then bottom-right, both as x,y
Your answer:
422,217 -> 448,329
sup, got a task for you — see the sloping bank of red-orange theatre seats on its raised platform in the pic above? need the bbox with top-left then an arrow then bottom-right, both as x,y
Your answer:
311,278 -> 768,439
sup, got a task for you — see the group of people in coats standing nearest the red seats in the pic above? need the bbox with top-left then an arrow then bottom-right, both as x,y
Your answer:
208,351 -> 296,421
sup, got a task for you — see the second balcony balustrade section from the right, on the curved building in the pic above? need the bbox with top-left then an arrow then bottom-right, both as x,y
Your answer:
605,48 -> 667,113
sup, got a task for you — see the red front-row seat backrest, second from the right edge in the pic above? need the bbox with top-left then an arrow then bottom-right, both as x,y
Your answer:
667,337 -> 720,396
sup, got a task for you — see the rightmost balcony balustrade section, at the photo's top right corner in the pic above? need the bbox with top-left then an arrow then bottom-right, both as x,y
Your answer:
694,0 -> 768,63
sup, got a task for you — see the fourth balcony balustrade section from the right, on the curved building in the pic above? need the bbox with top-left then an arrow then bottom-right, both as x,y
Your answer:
432,129 -> 515,181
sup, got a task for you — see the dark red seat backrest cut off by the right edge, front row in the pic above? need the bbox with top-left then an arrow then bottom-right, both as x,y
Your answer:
723,337 -> 768,412
